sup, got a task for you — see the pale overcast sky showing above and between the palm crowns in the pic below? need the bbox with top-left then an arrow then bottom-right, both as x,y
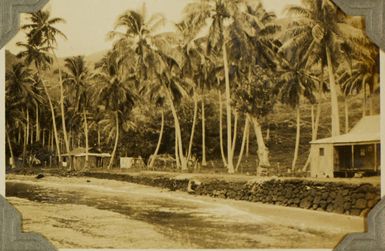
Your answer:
7,0 -> 300,57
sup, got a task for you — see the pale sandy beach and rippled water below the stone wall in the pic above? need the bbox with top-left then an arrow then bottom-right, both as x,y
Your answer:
7,175 -> 364,249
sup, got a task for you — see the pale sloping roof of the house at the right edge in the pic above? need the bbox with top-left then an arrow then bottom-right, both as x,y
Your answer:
310,115 -> 381,144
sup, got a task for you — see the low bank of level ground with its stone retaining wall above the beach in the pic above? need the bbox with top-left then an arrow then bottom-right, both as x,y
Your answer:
7,169 -> 380,217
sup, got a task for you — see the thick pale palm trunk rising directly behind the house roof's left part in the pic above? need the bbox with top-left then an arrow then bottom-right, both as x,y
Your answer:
326,47 -> 340,137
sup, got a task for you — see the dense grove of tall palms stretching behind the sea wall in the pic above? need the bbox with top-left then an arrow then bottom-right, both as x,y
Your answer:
6,0 -> 379,174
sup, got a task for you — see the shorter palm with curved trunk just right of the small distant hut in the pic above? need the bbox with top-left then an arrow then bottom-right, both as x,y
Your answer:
94,52 -> 135,169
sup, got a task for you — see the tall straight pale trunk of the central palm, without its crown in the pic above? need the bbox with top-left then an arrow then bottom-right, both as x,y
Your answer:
222,39 -> 235,174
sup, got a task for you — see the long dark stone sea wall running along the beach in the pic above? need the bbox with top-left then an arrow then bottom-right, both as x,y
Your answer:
82,173 -> 380,216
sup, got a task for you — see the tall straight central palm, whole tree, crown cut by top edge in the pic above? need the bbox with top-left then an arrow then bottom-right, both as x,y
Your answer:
185,0 -> 277,173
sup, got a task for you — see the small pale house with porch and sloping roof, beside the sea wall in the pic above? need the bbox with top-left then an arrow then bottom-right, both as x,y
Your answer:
310,115 -> 381,178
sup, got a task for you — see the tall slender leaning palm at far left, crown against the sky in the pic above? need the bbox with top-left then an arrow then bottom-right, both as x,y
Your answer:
22,10 -> 70,159
